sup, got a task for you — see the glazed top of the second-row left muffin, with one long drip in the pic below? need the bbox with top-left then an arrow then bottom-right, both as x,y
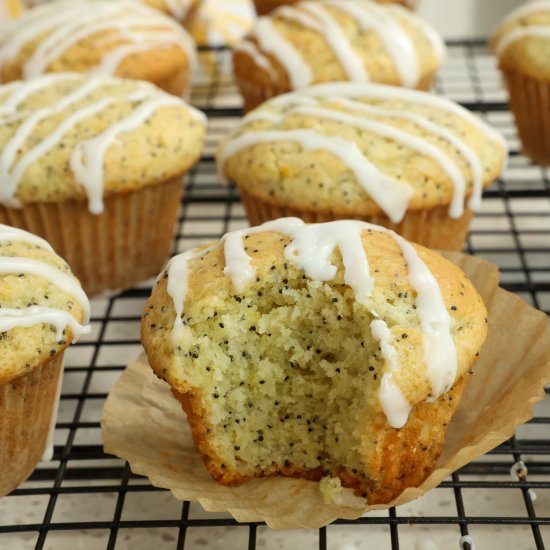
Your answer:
0,74 -> 206,214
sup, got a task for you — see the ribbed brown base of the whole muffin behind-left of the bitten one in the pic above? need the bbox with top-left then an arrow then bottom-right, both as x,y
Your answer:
0,177 -> 183,295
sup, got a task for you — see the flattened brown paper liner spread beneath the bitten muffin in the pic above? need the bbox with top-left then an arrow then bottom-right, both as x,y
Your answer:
102,253 -> 550,529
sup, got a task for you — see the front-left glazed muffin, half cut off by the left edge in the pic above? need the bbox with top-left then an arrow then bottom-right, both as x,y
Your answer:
0,225 -> 90,497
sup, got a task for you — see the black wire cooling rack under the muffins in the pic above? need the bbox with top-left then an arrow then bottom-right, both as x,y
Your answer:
0,41 -> 550,550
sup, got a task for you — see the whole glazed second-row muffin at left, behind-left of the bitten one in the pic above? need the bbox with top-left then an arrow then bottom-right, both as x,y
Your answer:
0,74 -> 205,294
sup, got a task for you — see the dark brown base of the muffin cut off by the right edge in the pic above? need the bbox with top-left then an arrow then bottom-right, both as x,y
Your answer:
502,69 -> 550,166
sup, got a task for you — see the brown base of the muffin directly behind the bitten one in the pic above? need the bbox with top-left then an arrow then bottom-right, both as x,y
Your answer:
240,190 -> 473,251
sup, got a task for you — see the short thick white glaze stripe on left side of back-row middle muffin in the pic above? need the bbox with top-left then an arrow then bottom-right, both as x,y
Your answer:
251,17 -> 313,90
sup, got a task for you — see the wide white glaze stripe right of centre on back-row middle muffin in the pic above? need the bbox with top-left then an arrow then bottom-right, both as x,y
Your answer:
323,0 -> 420,88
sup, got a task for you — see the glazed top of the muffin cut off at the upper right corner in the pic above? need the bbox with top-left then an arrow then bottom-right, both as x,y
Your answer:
491,0 -> 550,80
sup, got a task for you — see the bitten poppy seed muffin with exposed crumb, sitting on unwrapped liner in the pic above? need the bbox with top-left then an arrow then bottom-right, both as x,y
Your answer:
141,218 -> 487,504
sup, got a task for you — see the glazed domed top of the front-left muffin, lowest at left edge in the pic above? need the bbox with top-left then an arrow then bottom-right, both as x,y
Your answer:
0,225 -> 90,384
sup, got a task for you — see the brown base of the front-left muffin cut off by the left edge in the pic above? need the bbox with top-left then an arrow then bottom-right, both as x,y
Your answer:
0,353 -> 63,497
